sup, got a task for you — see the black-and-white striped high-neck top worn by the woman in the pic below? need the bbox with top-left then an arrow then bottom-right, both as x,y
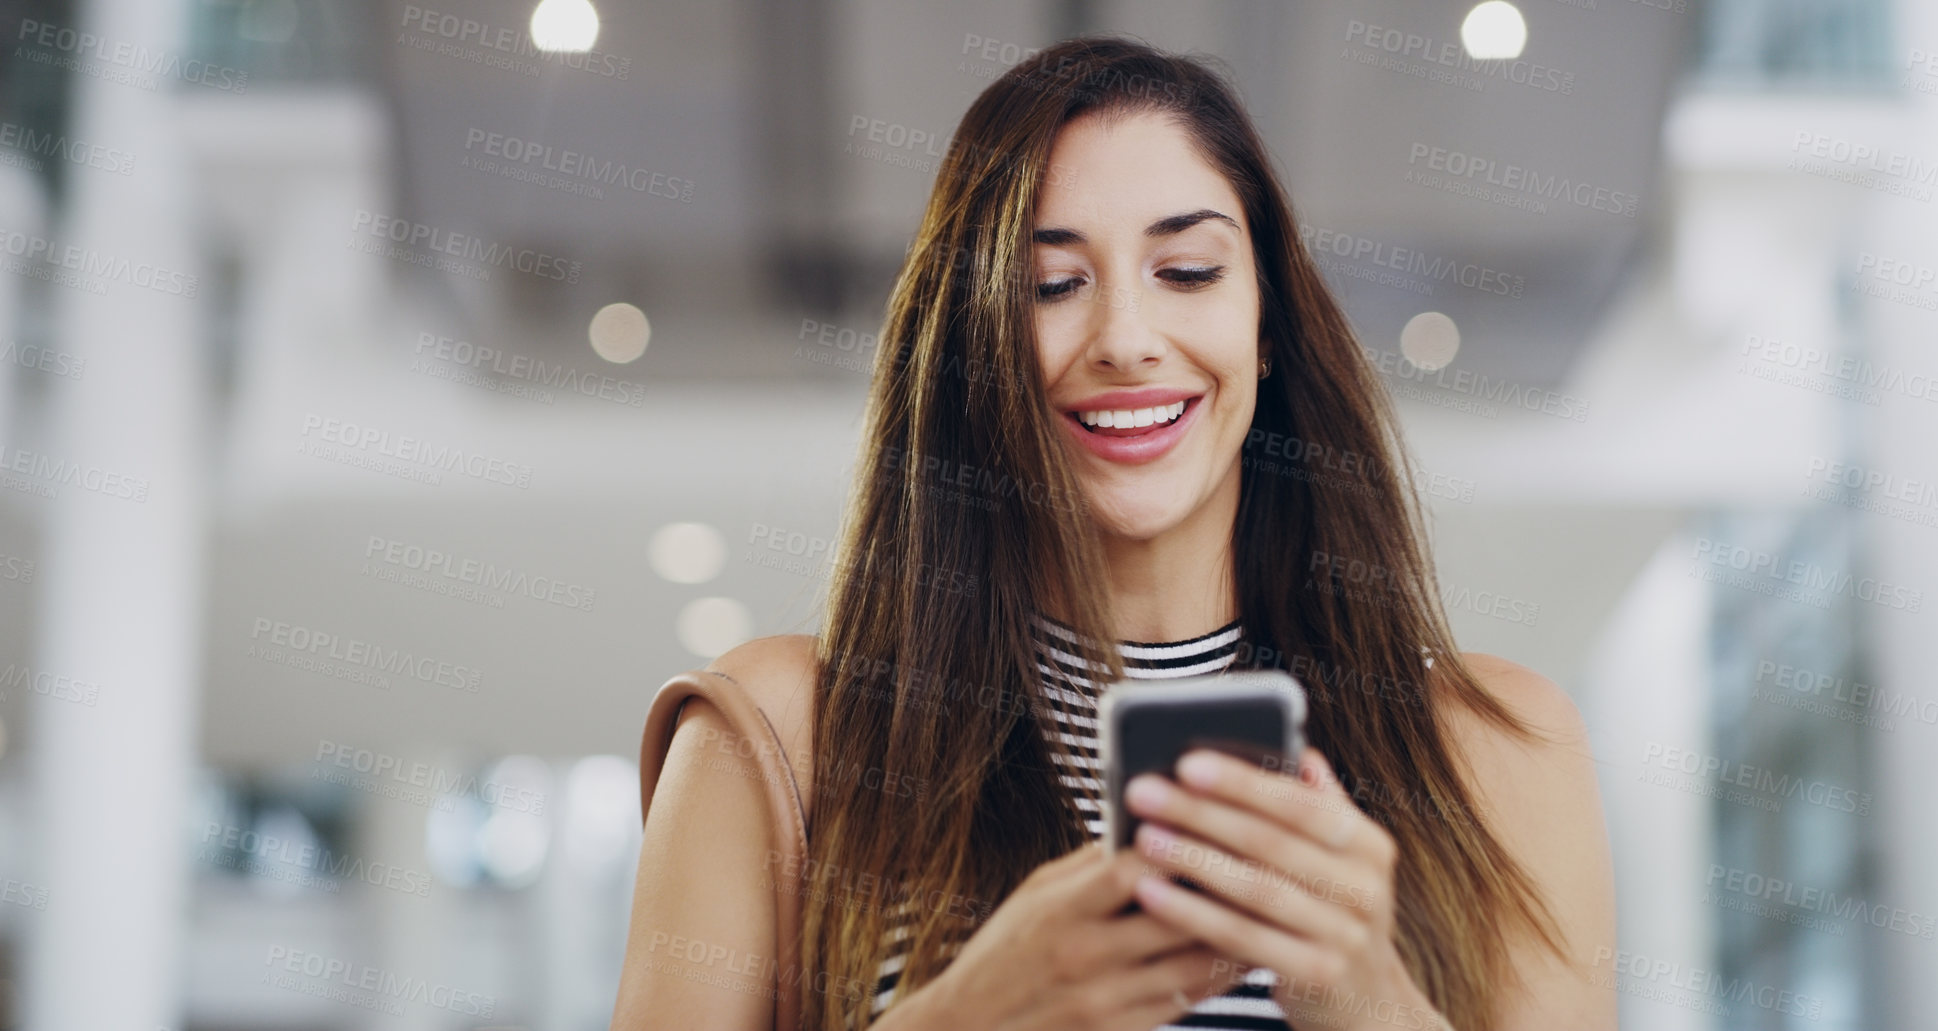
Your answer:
870,616 -> 1291,1031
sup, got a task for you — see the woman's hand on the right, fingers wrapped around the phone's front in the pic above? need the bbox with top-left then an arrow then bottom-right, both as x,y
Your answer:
1126,748 -> 1446,1031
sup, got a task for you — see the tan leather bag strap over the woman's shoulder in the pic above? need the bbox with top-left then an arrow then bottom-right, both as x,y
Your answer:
640,671 -> 808,1031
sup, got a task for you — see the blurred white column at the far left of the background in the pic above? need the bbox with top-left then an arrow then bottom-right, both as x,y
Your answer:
23,0 -> 207,1031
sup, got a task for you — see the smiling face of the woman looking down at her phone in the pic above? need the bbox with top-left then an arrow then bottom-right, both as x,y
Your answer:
1033,112 -> 1264,541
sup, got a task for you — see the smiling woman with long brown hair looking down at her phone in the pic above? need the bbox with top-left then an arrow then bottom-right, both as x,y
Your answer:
614,39 -> 1614,1031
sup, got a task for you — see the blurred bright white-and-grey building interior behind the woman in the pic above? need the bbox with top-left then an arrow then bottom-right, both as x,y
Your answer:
0,0 -> 1938,1031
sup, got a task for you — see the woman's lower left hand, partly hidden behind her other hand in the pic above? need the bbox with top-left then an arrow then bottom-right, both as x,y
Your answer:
872,843 -> 1225,1031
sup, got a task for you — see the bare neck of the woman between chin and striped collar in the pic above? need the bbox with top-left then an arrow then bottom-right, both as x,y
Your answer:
1103,469 -> 1238,641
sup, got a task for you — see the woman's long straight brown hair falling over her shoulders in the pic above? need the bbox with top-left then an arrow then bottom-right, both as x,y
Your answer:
800,37 -> 1560,1031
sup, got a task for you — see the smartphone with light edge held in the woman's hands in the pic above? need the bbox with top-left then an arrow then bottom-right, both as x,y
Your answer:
1097,669 -> 1306,855
